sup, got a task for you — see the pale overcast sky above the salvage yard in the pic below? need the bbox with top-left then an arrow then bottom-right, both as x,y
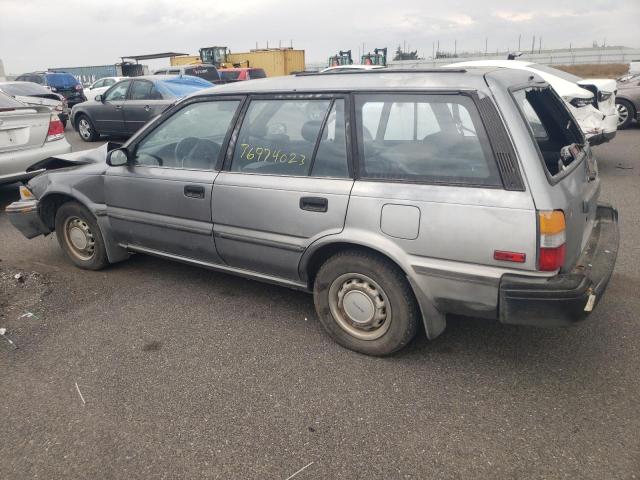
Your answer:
0,0 -> 640,73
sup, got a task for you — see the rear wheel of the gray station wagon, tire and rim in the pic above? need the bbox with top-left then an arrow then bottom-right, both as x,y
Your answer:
313,250 -> 421,356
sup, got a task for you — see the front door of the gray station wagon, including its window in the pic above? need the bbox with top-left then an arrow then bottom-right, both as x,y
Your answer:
105,97 -> 241,263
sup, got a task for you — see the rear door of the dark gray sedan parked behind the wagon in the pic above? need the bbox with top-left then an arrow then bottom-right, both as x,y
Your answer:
123,80 -> 170,134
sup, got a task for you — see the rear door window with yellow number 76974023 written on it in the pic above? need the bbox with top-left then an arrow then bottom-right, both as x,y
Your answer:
231,99 -> 344,176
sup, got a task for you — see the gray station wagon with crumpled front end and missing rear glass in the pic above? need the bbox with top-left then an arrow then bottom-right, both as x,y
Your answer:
7,68 -> 618,355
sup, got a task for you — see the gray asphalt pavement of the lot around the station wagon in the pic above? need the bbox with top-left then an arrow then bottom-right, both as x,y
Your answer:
0,125 -> 640,480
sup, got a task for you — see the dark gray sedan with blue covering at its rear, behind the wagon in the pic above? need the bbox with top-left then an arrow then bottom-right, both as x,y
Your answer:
71,75 -> 213,142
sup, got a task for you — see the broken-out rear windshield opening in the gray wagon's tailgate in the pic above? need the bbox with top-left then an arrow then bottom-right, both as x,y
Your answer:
513,88 -> 584,176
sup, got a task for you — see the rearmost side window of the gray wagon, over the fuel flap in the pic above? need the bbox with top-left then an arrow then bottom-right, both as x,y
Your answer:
356,94 -> 501,186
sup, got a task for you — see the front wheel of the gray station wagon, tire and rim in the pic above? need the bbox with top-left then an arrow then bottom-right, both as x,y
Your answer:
55,202 -> 109,270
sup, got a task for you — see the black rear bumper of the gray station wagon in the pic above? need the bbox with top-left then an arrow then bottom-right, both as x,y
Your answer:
499,205 -> 619,327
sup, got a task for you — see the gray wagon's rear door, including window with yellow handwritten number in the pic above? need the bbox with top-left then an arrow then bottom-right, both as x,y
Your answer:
213,95 -> 353,281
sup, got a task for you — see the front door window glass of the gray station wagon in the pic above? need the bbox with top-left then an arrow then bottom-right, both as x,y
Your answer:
135,100 -> 240,170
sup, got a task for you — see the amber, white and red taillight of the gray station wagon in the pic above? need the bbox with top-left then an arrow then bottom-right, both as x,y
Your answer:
538,210 -> 567,272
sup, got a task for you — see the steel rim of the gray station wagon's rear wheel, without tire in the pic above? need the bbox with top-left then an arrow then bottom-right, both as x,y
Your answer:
329,273 -> 392,340
